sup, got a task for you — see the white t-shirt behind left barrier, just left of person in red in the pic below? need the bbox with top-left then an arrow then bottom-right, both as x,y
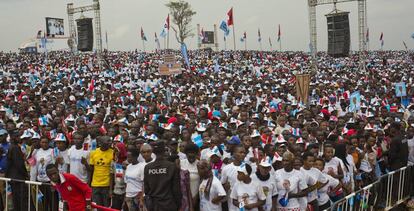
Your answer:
35,149 -> 55,182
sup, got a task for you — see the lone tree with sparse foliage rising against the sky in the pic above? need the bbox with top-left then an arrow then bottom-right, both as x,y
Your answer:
165,0 -> 196,44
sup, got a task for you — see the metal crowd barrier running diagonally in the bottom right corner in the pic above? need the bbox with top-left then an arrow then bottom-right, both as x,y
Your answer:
327,165 -> 414,211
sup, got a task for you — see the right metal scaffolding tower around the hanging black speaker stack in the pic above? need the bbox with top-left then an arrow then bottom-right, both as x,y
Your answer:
308,0 -> 367,70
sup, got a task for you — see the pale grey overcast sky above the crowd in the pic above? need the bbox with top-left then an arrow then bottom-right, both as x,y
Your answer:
0,0 -> 414,51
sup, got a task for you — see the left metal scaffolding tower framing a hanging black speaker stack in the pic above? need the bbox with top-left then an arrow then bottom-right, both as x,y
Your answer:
67,0 -> 103,70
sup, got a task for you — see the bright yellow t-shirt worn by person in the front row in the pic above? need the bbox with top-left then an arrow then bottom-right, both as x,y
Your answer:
89,148 -> 114,187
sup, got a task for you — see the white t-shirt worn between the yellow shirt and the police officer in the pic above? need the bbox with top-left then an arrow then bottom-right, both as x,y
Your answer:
124,163 -> 142,197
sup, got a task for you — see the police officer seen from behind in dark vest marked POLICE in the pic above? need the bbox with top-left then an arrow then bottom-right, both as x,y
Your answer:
144,140 -> 182,211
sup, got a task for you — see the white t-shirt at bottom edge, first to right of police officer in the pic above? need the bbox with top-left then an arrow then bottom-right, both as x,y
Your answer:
199,177 -> 226,211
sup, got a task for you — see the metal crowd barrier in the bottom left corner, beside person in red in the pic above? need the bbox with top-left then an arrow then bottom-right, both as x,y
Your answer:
0,177 -> 58,211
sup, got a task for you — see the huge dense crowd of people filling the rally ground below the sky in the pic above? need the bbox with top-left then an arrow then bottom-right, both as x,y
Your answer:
0,51 -> 414,211
